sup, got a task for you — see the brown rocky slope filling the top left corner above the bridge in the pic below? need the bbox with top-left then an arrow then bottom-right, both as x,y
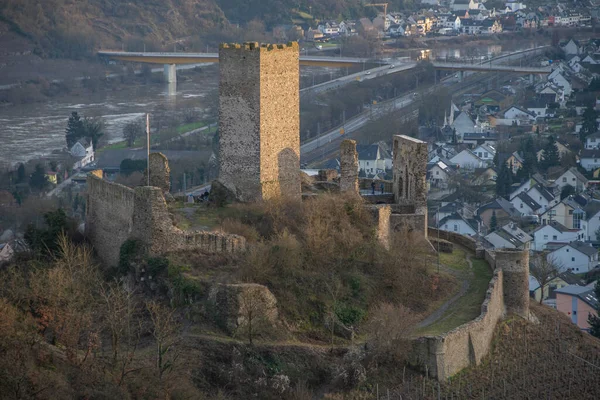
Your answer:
0,0 -> 226,58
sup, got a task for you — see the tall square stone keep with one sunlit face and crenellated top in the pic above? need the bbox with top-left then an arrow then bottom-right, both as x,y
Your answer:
219,42 -> 301,201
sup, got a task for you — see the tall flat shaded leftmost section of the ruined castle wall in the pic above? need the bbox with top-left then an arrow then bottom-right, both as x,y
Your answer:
85,171 -> 135,266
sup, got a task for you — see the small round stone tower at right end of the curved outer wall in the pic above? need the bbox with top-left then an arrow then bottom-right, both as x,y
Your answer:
496,249 -> 529,318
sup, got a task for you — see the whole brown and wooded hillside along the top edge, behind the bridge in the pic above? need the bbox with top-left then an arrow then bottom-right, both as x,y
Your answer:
0,0 -> 374,59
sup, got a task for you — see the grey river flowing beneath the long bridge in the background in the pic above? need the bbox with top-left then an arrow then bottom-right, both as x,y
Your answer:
0,42 -> 534,166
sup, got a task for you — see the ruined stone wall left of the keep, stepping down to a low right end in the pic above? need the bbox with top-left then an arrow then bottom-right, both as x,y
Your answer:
86,174 -> 246,265
